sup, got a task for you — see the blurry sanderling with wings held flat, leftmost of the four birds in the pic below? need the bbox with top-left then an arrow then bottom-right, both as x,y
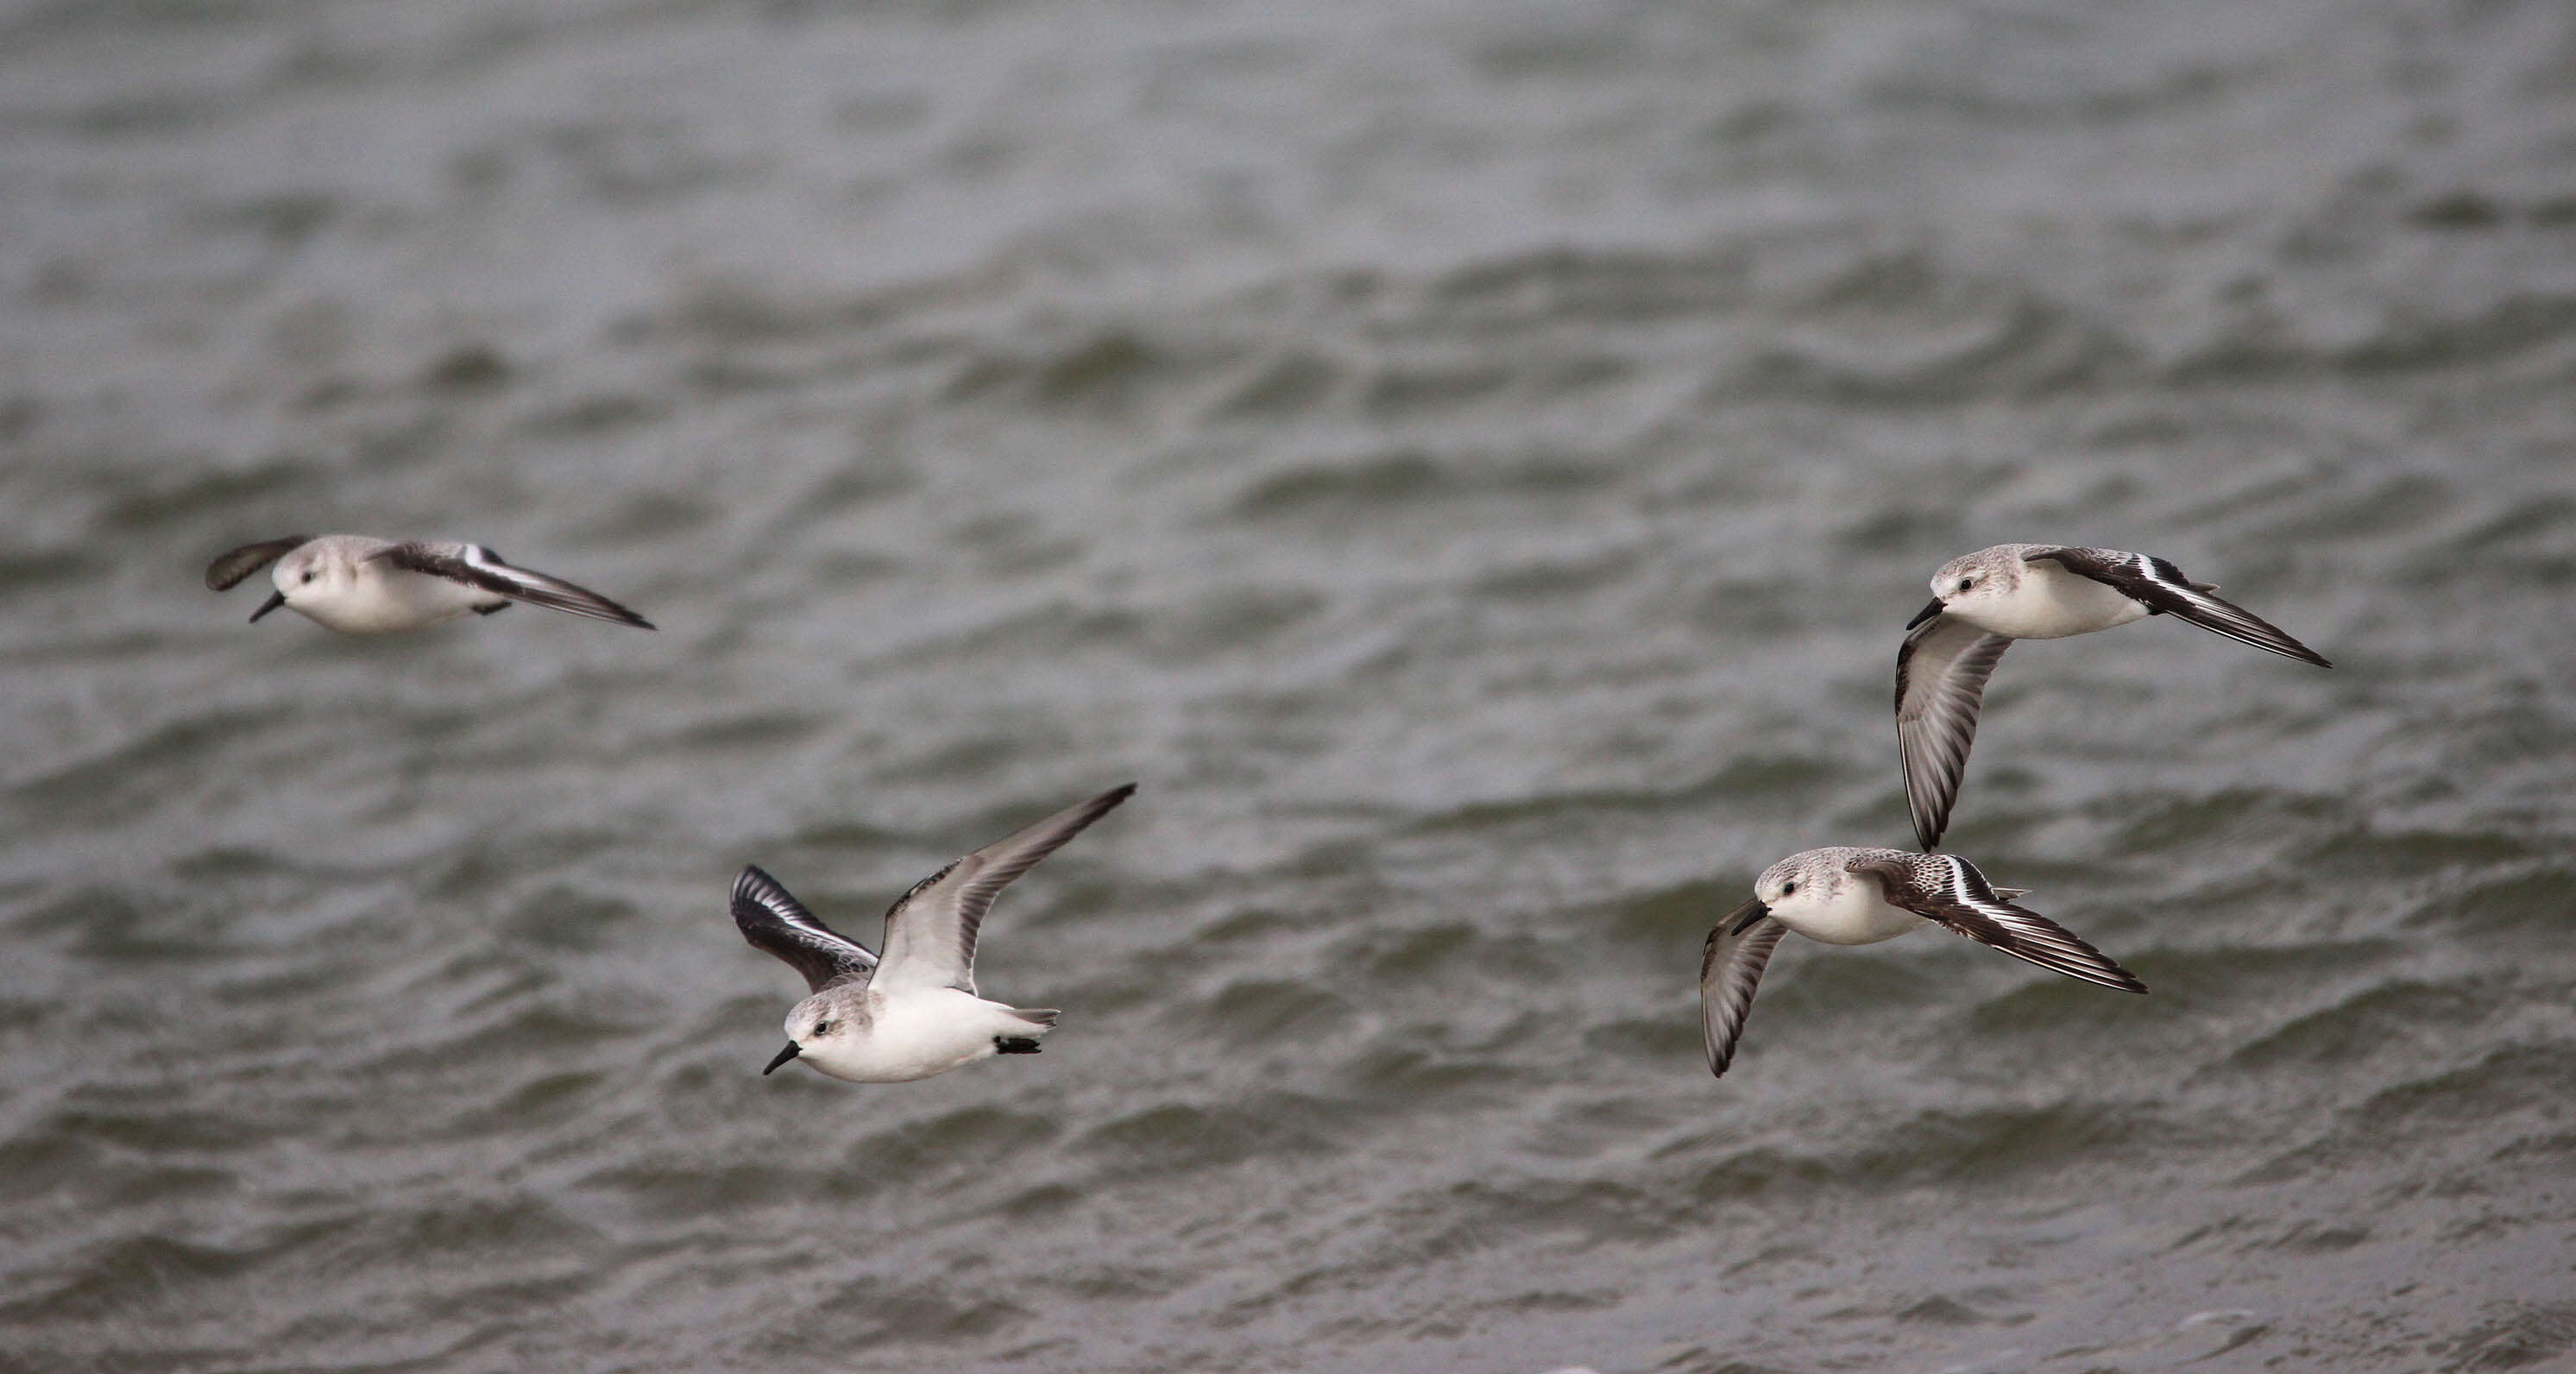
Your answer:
206,533 -> 652,634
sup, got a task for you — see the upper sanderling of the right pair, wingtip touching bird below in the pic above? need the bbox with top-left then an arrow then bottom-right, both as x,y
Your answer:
1896,544 -> 2334,851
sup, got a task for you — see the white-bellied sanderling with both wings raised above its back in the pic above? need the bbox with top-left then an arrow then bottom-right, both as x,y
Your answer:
734,784 -> 1136,1082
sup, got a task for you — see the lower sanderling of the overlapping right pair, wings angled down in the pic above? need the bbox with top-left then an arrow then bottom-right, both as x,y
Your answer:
1700,846 -> 2146,1075
